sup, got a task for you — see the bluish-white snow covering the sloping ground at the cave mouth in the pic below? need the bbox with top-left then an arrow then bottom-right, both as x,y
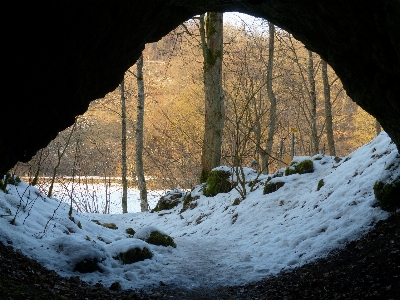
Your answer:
0,132 -> 400,290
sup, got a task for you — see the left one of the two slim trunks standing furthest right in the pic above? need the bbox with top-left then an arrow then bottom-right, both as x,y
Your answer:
308,50 -> 319,155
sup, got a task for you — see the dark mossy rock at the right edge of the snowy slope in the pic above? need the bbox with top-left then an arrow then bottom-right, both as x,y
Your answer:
374,179 -> 400,211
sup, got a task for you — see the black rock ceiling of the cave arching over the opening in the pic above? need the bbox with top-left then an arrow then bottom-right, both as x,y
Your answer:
0,0 -> 400,172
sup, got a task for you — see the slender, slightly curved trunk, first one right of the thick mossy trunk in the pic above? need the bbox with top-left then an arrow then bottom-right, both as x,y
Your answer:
263,22 -> 276,174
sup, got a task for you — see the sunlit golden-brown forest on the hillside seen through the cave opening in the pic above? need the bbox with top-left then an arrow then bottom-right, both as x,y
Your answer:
12,15 -> 381,209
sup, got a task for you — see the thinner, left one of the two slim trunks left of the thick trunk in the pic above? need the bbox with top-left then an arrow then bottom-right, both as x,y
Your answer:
120,79 -> 128,214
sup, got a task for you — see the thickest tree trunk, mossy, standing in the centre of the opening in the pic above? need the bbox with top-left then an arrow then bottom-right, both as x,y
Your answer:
200,12 -> 225,181
